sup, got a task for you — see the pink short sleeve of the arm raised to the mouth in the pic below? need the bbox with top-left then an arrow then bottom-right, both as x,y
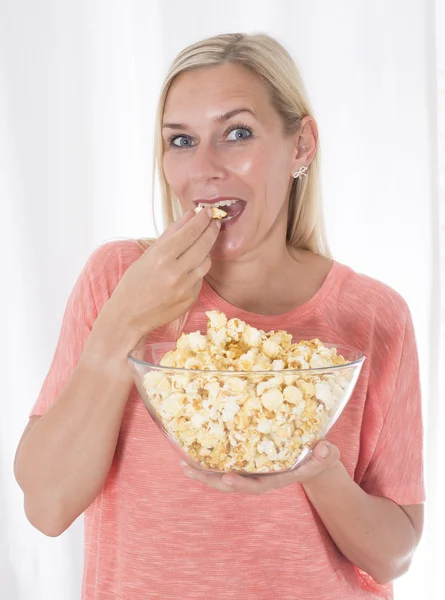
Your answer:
29,242 -> 140,416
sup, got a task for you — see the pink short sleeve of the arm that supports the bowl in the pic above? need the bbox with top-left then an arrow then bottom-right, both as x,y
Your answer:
360,308 -> 425,505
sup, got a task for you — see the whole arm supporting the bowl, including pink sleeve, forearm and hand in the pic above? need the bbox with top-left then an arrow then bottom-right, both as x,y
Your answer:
183,298 -> 424,584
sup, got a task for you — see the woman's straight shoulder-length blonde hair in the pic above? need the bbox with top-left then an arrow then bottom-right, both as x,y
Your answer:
138,33 -> 332,258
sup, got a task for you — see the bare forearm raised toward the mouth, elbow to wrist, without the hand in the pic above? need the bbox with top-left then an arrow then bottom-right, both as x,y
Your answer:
15,316 -> 140,535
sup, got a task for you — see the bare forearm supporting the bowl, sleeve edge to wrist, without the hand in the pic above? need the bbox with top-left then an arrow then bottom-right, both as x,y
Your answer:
303,461 -> 417,583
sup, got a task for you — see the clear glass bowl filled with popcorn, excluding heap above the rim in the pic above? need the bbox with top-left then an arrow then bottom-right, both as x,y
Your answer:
128,336 -> 365,476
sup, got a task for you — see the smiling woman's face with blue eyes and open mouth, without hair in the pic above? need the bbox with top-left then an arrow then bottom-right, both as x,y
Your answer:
162,64 -> 297,260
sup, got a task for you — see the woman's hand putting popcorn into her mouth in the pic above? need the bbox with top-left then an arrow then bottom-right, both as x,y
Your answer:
99,210 -> 221,338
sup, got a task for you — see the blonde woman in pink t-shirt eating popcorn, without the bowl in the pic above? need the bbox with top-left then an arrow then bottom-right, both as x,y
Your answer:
15,34 -> 424,600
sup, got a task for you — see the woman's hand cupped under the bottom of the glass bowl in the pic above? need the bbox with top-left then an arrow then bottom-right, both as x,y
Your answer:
182,440 -> 340,495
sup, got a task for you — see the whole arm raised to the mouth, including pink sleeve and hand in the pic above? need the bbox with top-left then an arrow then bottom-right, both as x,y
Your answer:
15,211 -> 219,536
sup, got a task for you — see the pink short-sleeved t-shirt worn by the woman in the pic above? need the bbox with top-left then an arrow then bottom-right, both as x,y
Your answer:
31,241 -> 425,600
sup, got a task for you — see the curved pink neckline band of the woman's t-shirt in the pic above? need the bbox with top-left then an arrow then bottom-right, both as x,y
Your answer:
201,259 -> 342,323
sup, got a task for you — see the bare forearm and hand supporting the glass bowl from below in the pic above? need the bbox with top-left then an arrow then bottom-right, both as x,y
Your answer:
183,441 -> 423,584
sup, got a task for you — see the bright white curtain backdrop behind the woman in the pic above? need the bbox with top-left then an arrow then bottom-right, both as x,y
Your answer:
0,0 -> 445,600
